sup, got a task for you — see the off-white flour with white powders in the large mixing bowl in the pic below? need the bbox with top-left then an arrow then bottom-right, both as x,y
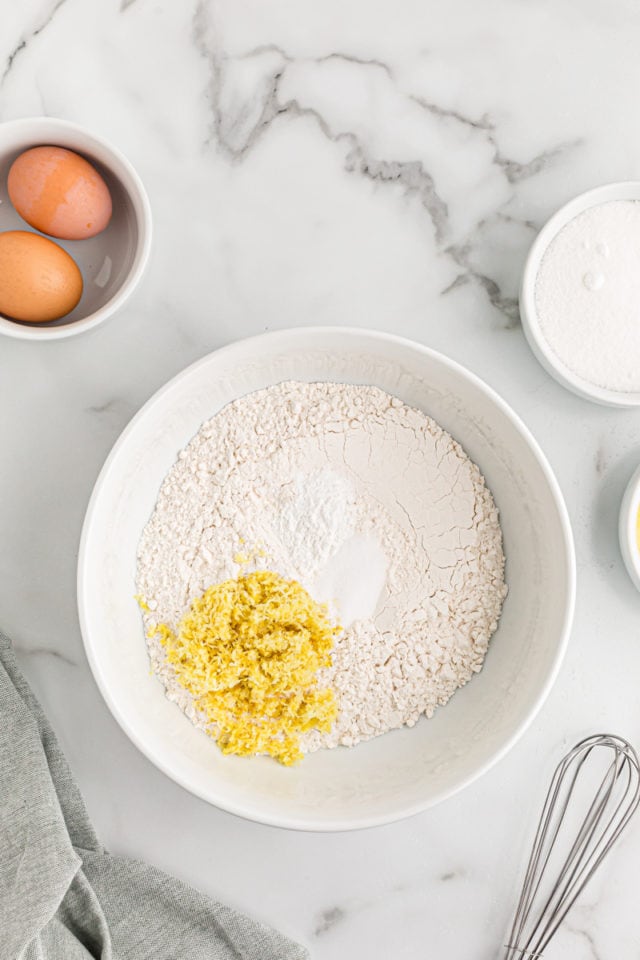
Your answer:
137,382 -> 506,752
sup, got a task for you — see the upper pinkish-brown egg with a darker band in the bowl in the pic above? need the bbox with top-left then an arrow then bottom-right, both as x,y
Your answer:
7,147 -> 112,240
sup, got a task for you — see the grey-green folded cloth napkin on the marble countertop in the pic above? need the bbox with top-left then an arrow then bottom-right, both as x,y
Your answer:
0,633 -> 308,960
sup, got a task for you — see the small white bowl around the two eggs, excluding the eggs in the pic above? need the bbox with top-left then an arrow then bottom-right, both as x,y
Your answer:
0,117 -> 151,340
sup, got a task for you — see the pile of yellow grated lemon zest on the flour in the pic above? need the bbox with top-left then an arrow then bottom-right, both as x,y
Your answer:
151,570 -> 341,766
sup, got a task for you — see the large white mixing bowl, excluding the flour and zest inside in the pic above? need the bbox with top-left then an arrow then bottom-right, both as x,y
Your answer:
78,328 -> 575,830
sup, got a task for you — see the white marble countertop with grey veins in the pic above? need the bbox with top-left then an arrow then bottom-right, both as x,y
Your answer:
0,0 -> 640,960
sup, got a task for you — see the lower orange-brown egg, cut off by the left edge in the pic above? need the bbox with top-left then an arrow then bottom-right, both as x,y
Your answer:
0,230 -> 82,323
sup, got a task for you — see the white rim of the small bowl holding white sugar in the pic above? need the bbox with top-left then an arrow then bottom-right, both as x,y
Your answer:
520,180 -> 640,407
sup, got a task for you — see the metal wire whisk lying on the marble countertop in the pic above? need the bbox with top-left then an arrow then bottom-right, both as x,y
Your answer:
504,734 -> 640,960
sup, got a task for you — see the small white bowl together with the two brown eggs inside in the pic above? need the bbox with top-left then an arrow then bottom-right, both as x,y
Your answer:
0,117 -> 151,340
